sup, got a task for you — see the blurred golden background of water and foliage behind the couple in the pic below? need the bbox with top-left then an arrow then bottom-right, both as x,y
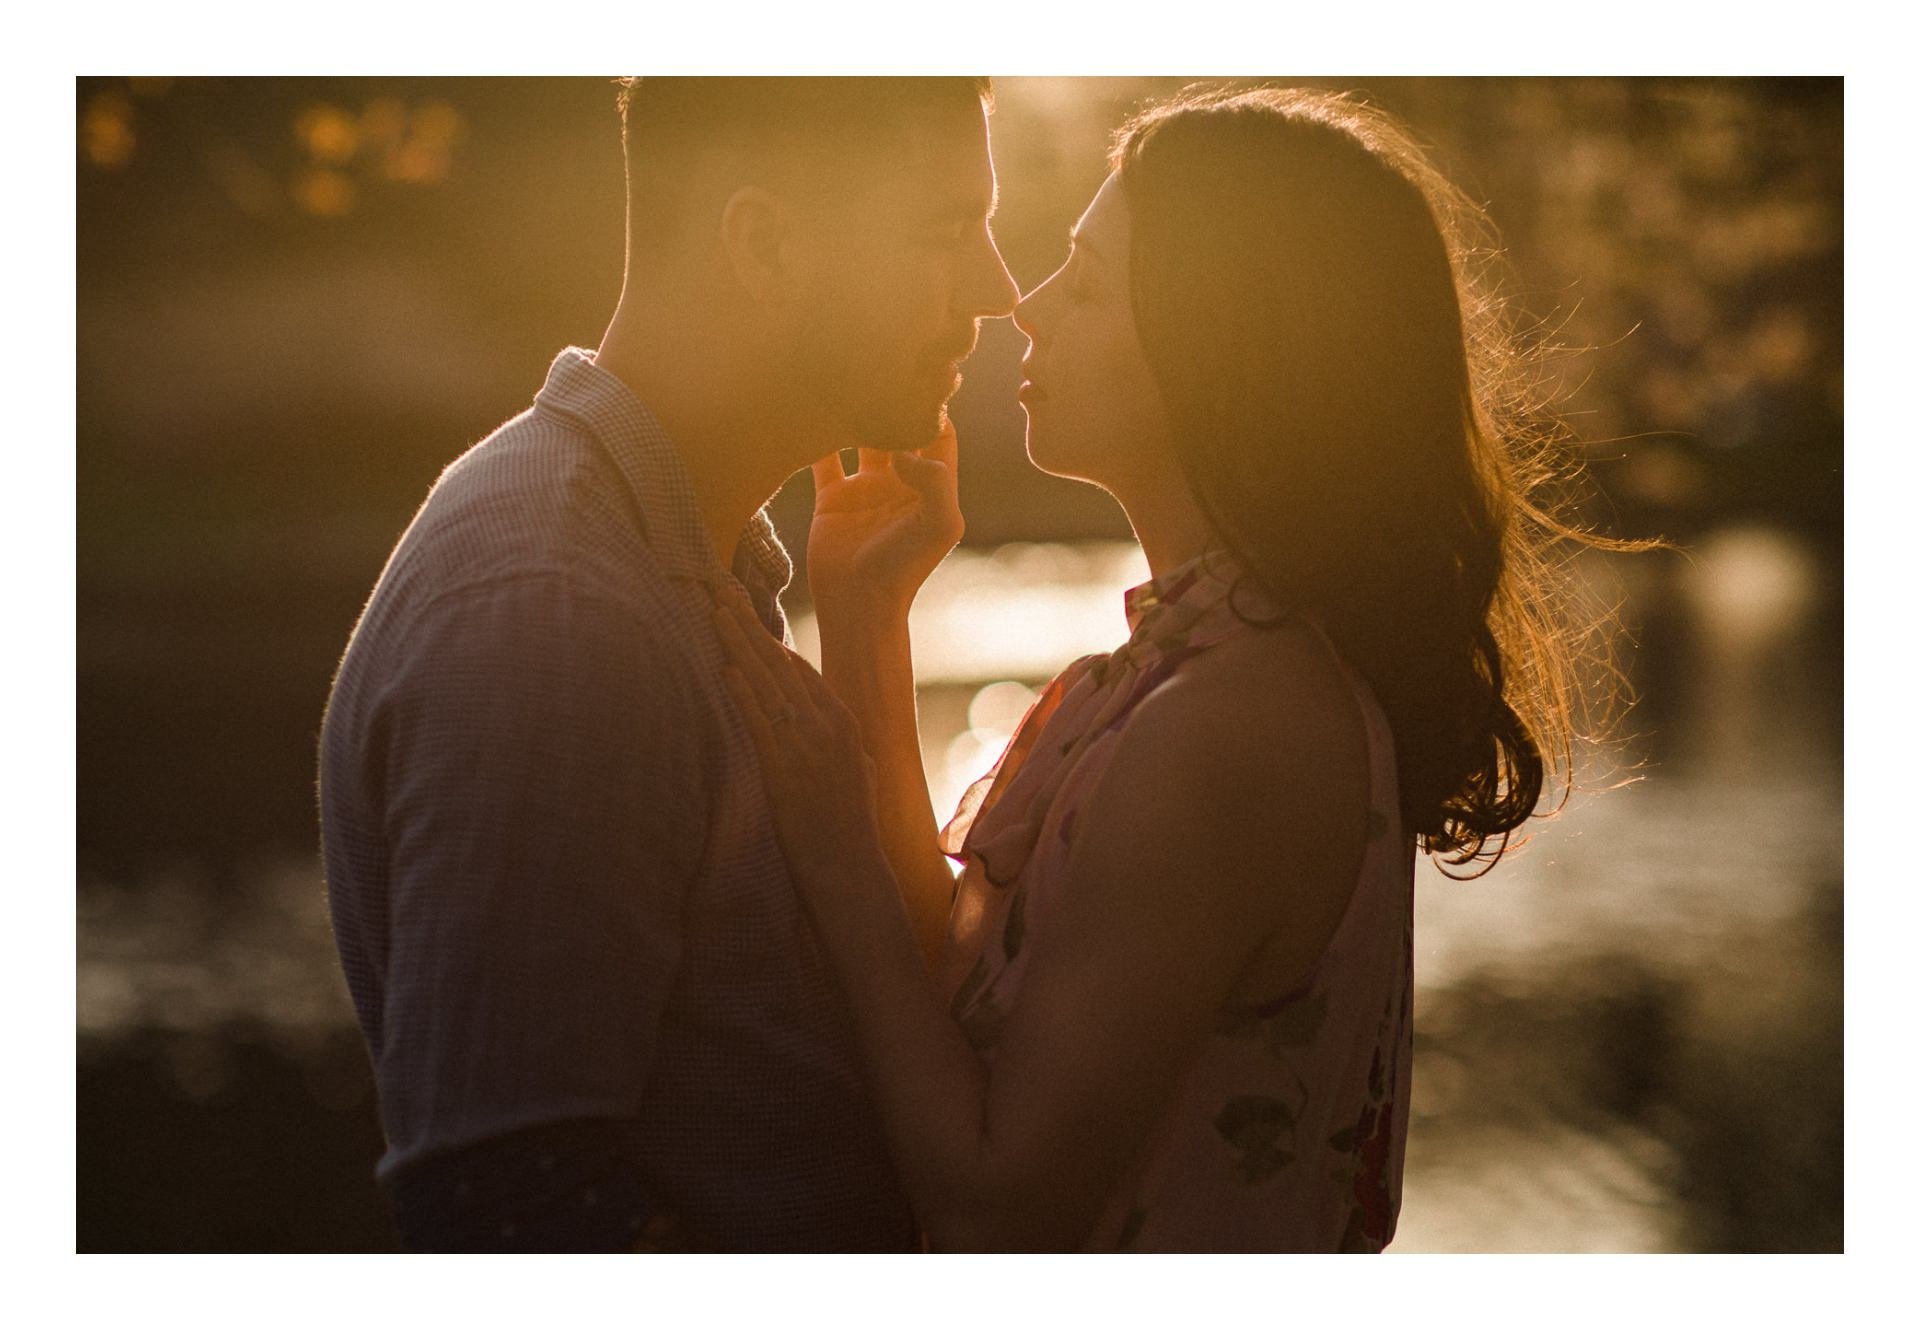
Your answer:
75,79 -> 1841,1251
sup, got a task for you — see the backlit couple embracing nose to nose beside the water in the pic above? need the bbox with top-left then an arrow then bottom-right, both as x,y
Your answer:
321,79 -> 1569,1251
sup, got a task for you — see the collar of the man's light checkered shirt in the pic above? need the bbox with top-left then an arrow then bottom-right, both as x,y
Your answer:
534,345 -> 793,616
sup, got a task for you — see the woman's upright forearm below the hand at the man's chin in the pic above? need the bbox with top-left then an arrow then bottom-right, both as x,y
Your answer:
820,608 -> 954,967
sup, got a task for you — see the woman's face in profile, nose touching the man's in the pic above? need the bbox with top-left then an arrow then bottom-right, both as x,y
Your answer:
1014,177 -> 1169,493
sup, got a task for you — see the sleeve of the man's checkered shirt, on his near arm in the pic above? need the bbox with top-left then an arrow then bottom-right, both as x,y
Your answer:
378,576 -> 708,1167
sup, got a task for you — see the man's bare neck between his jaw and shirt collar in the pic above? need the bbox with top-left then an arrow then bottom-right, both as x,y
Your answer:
593,301 -> 828,568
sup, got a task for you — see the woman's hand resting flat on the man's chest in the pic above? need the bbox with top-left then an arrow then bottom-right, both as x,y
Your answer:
714,591 -> 891,908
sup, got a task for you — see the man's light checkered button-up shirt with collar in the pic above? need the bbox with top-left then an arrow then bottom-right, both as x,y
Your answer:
321,347 -> 914,1249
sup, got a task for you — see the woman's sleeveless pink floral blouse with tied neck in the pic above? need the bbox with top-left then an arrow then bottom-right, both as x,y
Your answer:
941,551 -> 1413,1251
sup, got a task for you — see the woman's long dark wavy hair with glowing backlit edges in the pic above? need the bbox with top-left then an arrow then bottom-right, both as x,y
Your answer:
1112,88 -> 1628,871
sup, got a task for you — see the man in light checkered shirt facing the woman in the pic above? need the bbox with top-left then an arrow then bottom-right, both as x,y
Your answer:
321,79 -> 1016,1249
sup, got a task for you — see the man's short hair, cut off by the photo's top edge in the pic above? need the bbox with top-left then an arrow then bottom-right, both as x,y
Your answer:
620,77 -> 993,257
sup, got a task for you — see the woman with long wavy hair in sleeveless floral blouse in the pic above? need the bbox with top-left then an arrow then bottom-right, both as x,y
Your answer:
716,90 -> 1612,1251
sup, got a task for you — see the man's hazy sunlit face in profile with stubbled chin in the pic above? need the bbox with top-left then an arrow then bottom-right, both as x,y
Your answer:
793,106 -> 1020,449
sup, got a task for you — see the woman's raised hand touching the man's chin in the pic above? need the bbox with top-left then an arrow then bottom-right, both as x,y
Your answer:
806,416 -> 966,622
